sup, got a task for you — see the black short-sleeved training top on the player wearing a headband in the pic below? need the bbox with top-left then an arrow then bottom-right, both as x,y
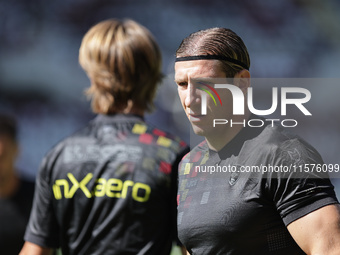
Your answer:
178,122 -> 337,255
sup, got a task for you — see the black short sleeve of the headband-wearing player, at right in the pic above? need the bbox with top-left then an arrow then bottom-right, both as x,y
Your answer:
267,139 -> 338,226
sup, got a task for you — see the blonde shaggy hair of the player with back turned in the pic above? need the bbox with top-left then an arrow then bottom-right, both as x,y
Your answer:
79,19 -> 162,114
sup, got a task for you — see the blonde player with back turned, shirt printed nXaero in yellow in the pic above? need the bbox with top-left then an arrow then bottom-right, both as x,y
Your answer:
21,20 -> 187,255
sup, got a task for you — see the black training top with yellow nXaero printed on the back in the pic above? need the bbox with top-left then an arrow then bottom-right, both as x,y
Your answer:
25,115 -> 187,255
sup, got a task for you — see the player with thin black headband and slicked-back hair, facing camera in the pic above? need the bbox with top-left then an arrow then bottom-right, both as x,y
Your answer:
175,28 -> 340,255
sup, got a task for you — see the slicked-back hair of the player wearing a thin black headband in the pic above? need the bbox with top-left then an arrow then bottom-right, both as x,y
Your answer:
176,27 -> 250,77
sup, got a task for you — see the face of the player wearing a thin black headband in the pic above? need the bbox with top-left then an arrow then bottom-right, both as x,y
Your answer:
175,60 -> 232,137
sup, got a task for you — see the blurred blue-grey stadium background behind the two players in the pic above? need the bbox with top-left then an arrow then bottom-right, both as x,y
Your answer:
0,0 -> 340,197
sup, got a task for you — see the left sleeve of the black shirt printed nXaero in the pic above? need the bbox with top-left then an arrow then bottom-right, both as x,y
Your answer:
24,152 -> 59,248
